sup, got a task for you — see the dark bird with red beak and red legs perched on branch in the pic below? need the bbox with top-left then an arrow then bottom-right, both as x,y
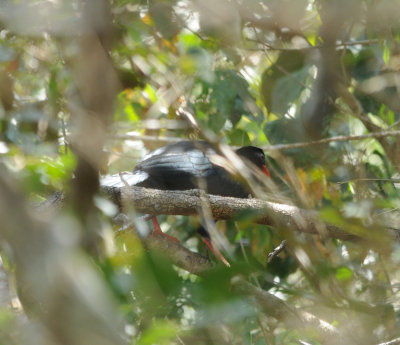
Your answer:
101,140 -> 270,266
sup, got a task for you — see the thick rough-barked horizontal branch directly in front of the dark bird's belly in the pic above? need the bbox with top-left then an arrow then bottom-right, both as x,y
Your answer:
103,186 -> 388,240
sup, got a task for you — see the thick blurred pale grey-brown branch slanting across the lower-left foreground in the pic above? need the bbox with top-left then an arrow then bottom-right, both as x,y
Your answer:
0,169 -> 125,345
